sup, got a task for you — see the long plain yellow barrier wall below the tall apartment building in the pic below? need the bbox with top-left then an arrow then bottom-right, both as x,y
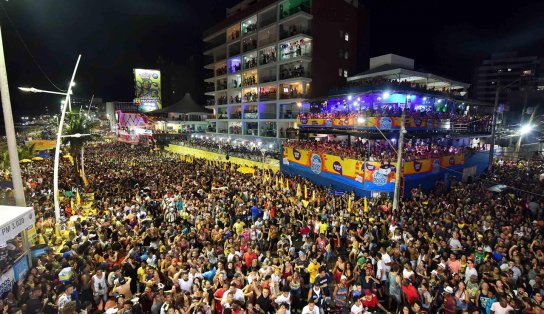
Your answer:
166,144 -> 280,172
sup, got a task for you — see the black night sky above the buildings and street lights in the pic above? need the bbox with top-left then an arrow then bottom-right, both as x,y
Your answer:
0,0 -> 544,115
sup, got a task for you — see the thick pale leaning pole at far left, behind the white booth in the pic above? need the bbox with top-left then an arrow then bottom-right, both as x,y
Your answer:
0,29 -> 26,206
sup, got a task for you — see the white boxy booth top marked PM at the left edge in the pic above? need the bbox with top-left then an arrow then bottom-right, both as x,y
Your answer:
0,206 -> 36,245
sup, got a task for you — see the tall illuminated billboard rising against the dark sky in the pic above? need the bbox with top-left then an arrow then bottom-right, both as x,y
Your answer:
134,69 -> 162,112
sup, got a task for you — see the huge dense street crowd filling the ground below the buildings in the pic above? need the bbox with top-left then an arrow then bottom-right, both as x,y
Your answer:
3,143 -> 544,314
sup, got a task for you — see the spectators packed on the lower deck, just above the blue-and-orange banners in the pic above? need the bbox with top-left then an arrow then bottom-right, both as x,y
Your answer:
284,138 -> 480,163
